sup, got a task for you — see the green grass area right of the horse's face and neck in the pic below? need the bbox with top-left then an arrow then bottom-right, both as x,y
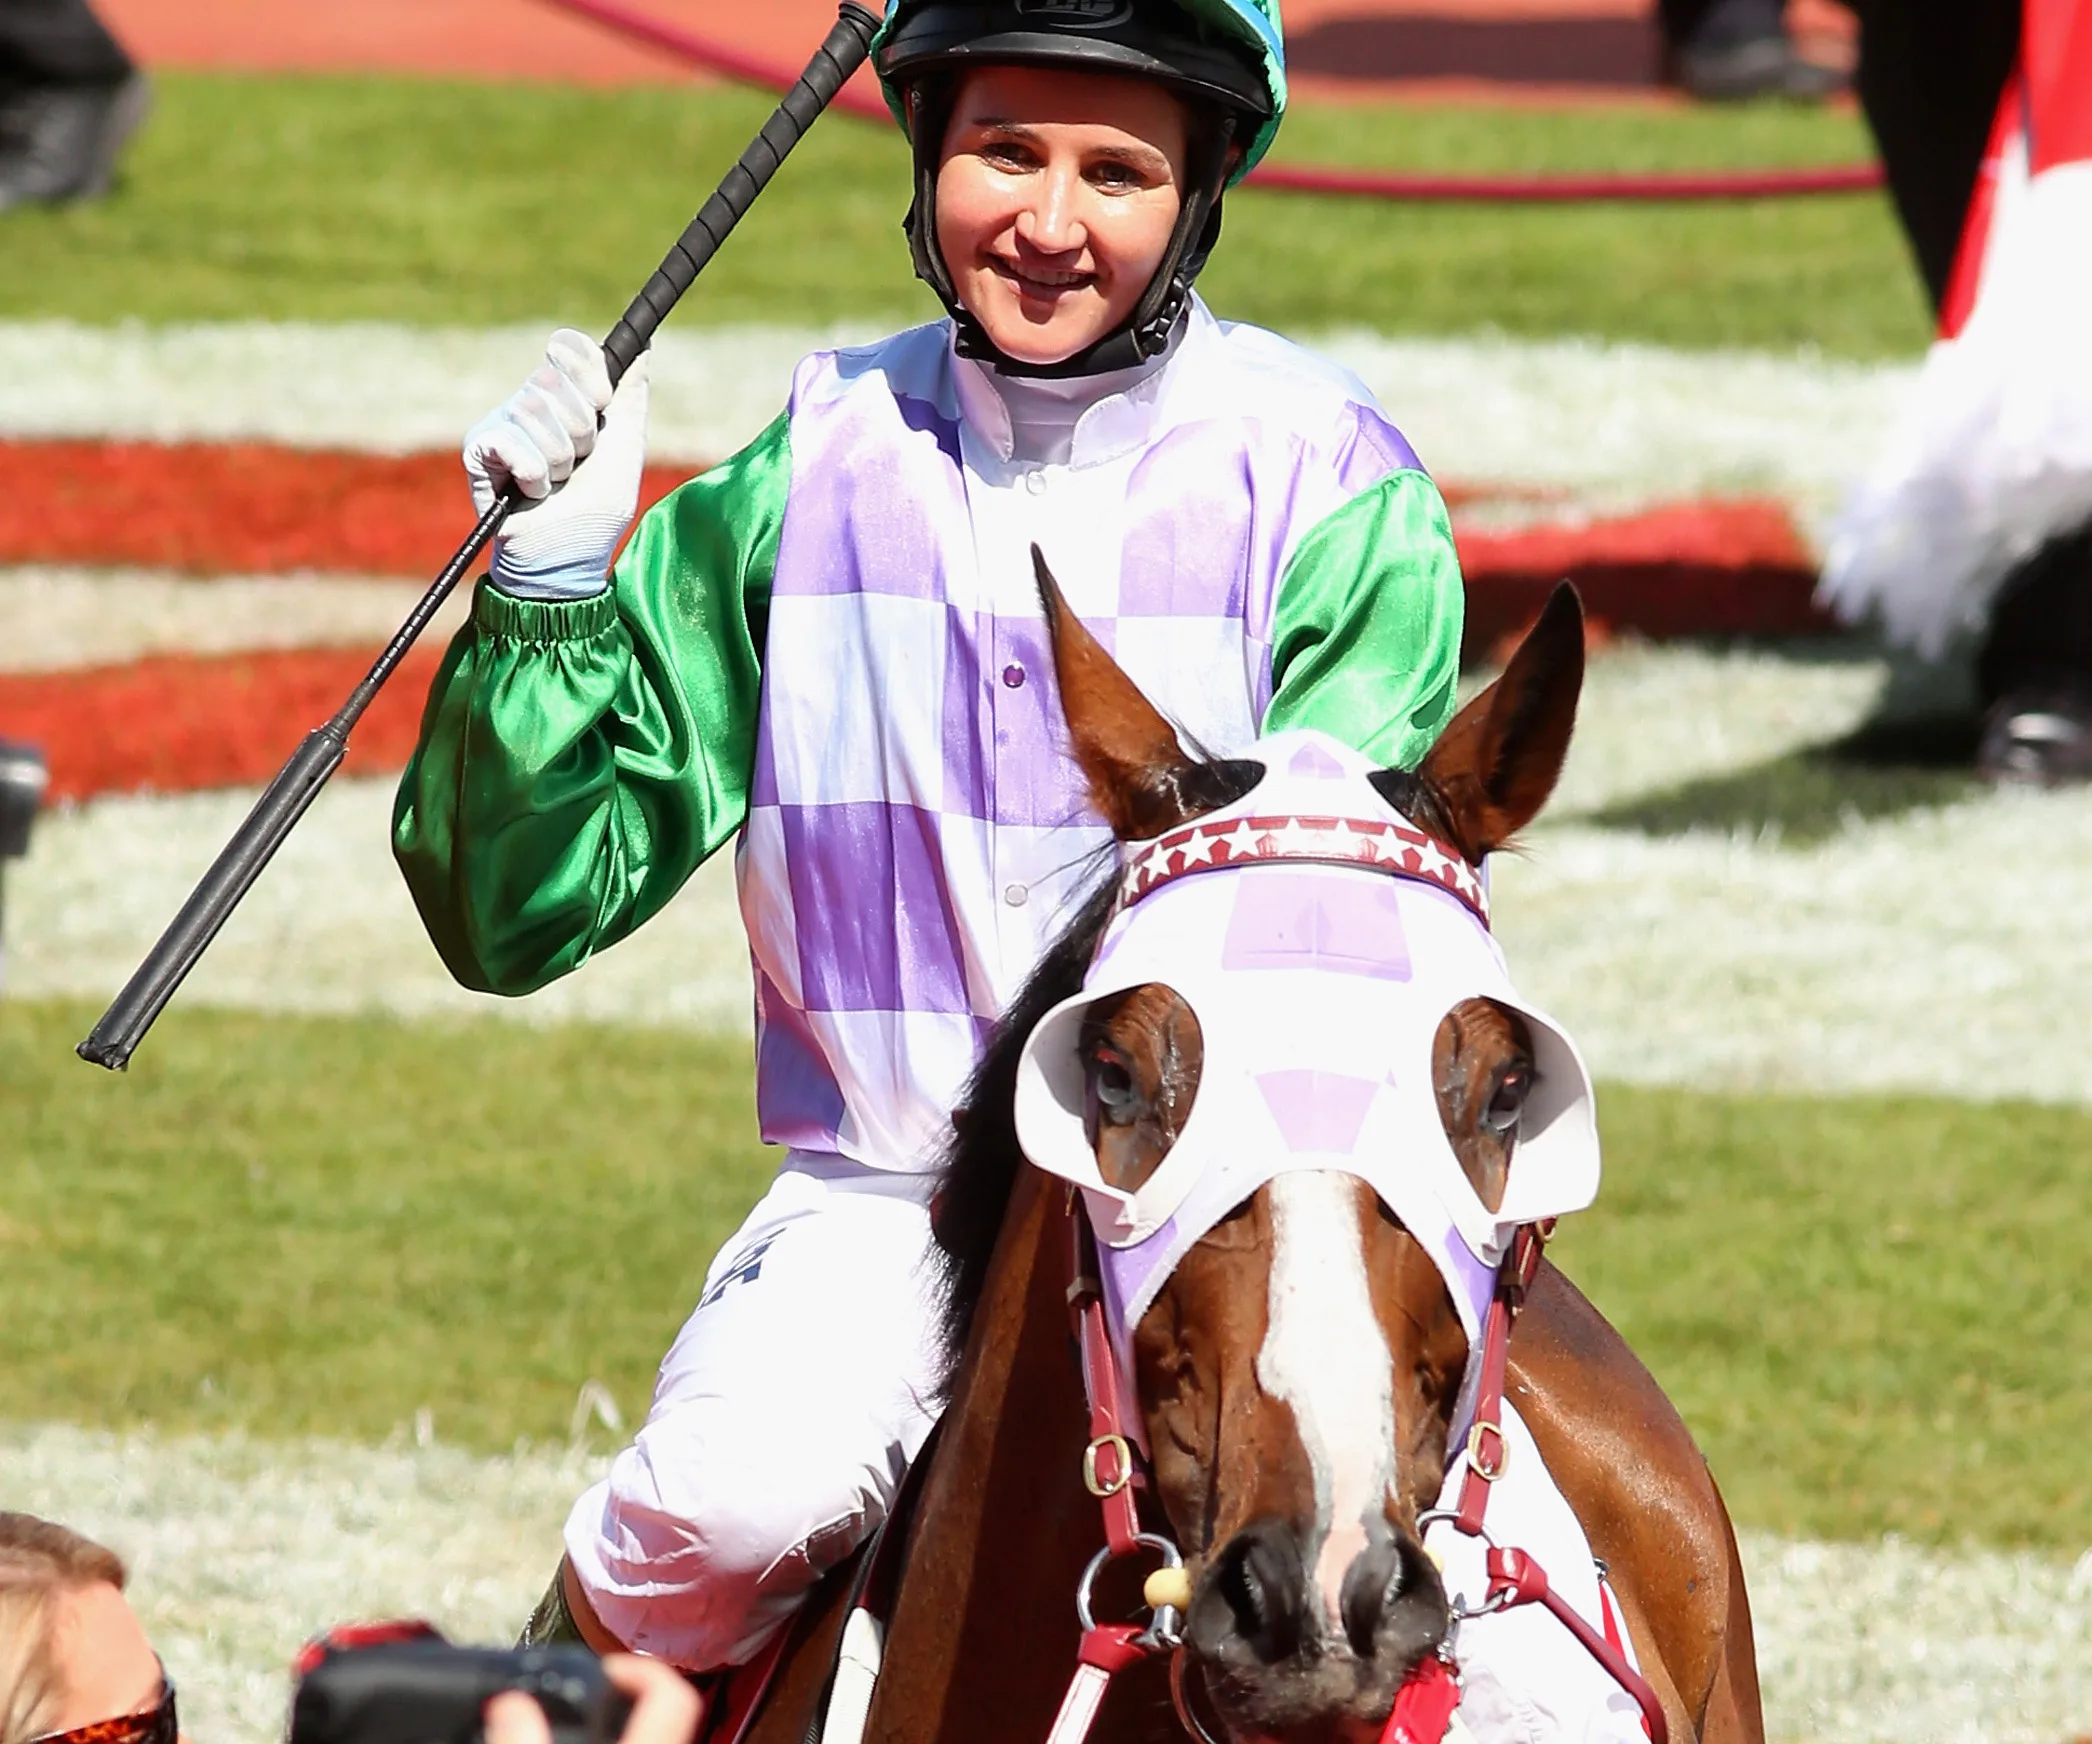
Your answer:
1559,1087 -> 2092,1554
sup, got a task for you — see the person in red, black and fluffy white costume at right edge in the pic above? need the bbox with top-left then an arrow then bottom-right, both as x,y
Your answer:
1822,0 -> 2092,786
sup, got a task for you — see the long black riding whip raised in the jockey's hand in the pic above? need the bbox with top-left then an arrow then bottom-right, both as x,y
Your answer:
77,0 -> 879,1071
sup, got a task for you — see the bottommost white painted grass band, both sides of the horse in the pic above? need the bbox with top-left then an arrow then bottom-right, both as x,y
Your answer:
0,1426 -> 2092,1744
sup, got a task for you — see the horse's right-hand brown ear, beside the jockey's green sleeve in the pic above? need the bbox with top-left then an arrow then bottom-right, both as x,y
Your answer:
1416,581 -> 1584,866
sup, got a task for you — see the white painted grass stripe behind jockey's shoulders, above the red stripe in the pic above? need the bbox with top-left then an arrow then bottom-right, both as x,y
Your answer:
0,322 -> 1916,527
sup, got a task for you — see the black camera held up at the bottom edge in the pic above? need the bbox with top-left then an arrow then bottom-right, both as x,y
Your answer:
289,1639 -> 632,1744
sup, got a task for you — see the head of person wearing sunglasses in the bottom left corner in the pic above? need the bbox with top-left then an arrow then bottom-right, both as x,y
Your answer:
0,1512 -> 180,1744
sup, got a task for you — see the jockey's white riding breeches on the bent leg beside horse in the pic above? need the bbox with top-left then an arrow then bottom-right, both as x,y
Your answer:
567,1152 -> 939,1671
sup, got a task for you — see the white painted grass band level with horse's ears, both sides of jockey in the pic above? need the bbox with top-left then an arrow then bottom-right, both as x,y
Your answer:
8,648 -> 2092,1102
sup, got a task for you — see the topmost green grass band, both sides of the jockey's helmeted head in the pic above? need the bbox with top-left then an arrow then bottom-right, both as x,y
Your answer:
0,73 -> 1927,358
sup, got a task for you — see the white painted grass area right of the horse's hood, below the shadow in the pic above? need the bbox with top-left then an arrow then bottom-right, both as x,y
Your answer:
1492,793 -> 2092,1104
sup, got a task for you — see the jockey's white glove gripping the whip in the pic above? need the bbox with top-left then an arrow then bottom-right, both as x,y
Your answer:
464,326 -> 651,600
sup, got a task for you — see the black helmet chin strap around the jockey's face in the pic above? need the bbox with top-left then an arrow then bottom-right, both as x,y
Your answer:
902,79 -> 1236,381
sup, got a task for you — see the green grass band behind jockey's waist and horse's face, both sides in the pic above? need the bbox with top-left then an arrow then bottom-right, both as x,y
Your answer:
0,1004 -> 2092,1550
